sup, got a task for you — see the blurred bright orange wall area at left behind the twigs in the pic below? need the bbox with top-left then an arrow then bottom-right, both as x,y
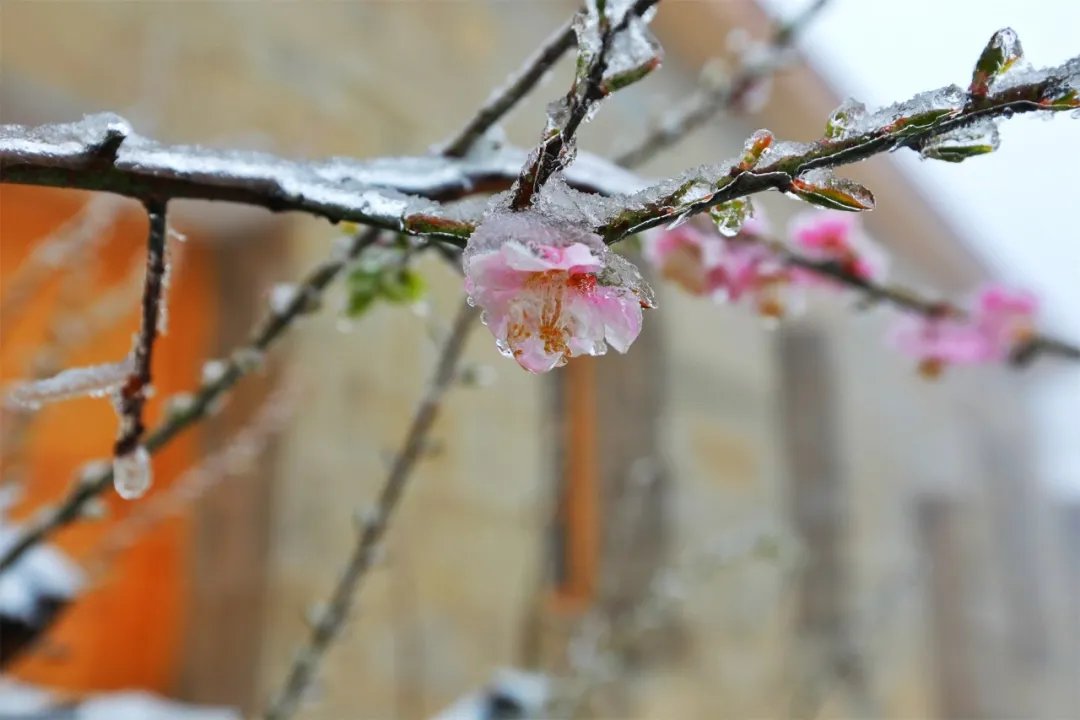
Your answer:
0,186 -> 215,691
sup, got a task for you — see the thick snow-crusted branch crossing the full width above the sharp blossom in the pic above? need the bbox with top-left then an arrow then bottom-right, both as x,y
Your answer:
0,50 -> 1080,246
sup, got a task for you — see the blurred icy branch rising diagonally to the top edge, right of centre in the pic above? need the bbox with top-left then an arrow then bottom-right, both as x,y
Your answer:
615,0 -> 828,167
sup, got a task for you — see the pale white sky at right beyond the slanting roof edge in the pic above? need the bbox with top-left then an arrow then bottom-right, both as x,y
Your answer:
762,0 -> 1080,492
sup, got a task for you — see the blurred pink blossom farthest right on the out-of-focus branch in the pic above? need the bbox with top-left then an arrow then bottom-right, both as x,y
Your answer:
892,285 -> 1038,376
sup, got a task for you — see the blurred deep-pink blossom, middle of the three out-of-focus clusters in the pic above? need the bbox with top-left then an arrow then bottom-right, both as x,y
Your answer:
788,210 -> 886,286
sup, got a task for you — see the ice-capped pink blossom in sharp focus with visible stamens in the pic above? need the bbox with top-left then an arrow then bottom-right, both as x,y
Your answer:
464,210 -> 653,372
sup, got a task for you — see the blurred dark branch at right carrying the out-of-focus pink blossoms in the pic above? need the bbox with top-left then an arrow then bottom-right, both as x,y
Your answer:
758,239 -> 1080,366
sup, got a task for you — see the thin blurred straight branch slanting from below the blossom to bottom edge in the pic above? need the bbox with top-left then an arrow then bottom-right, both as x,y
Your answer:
265,302 -> 477,720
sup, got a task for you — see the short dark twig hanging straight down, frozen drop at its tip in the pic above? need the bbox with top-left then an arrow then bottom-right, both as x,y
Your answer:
112,201 -> 168,458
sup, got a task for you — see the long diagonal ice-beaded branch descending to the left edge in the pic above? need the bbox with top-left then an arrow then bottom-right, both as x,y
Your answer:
0,229 -> 379,573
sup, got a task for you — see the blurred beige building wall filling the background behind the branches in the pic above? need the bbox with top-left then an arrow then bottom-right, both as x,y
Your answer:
0,0 -> 1080,720
